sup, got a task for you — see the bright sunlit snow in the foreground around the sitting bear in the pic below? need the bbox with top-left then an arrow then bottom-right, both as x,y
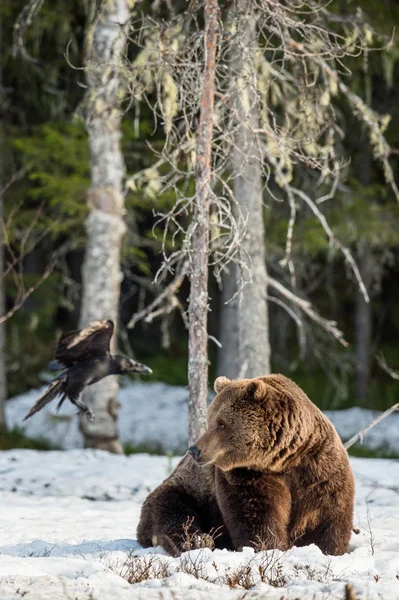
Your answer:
0,450 -> 399,600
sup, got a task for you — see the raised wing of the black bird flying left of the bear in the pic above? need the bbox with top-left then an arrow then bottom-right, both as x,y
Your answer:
55,320 -> 114,367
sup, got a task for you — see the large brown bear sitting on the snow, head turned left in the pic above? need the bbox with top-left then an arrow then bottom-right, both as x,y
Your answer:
137,375 -> 354,555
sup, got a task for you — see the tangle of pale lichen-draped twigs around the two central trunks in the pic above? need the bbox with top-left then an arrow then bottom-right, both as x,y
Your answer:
124,2 -> 395,318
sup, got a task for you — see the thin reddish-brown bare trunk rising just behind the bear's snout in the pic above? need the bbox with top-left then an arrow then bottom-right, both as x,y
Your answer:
188,0 -> 219,445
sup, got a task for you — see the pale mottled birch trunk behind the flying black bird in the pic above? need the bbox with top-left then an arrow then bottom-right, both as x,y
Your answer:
80,0 -> 131,452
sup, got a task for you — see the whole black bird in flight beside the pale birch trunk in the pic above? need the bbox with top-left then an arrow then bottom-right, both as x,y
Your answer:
24,321 -> 152,421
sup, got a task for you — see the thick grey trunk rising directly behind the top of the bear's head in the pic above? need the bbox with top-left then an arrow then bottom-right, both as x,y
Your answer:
221,0 -> 270,378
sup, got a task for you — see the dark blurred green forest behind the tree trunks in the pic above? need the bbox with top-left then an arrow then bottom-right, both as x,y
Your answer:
0,0 -> 399,409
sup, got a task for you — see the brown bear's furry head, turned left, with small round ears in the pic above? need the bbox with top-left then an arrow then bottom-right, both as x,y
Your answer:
190,375 -> 317,472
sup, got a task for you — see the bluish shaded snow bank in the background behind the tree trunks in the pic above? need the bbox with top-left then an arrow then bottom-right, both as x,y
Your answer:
6,383 -> 399,453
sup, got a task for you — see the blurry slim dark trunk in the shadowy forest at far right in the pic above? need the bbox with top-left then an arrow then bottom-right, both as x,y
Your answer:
355,240 -> 372,406
